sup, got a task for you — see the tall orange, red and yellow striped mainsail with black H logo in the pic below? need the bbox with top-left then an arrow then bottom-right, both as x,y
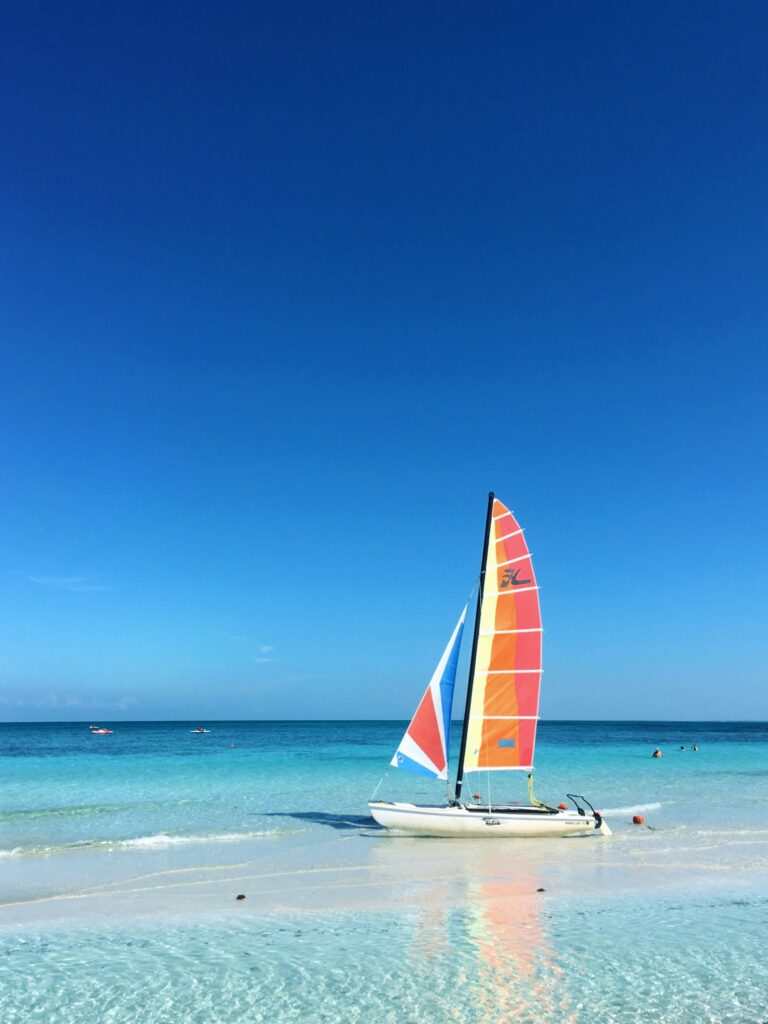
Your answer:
463,499 -> 542,772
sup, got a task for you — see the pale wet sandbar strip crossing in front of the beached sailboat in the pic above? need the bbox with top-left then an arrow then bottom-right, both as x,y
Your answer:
0,822 -> 768,928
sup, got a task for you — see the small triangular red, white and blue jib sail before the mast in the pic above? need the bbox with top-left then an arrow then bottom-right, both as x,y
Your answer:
390,605 -> 467,779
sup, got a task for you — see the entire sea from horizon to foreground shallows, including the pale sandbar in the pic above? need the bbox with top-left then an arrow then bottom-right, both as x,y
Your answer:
0,722 -> 768,1024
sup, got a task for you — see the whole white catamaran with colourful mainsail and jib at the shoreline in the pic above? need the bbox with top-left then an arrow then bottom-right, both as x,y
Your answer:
369,493 -> 609,838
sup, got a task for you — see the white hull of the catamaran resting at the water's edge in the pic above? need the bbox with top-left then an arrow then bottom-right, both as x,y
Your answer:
368,800 -> 604,839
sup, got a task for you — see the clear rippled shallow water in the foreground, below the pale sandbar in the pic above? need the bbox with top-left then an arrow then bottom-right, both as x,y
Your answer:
0,885 -> 768,1024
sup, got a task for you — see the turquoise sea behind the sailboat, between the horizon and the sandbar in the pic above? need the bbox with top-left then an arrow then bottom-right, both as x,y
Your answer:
0,722 -> 768,857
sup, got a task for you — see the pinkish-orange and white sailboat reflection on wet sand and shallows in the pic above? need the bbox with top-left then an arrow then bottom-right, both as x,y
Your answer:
375,840 -> 581,1024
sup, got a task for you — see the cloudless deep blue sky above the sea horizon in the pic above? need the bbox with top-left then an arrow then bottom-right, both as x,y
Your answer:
0,2 -> 768,721
